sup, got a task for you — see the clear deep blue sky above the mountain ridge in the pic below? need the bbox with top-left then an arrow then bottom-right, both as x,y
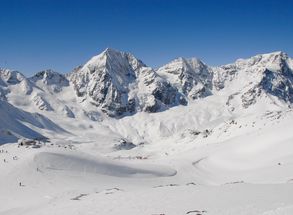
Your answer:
0,0 -> 293,75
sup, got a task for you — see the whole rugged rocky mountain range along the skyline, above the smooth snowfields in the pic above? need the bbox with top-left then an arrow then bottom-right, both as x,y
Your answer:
0,48 -> 293,142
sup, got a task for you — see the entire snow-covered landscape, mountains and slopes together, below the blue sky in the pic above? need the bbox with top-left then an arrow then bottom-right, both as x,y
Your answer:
0,49 -> 293,215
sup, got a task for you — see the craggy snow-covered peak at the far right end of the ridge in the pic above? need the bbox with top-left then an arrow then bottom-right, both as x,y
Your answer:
213,52 -> 293,108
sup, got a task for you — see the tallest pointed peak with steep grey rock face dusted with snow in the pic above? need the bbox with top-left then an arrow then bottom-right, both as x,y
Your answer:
69,49 -> 185,116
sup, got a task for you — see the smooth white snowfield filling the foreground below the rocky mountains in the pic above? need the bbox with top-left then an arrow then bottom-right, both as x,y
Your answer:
0,104 -> 293,215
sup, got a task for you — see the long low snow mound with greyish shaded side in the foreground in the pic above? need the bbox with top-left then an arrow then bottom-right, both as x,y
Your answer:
34,152 -> 176,178
